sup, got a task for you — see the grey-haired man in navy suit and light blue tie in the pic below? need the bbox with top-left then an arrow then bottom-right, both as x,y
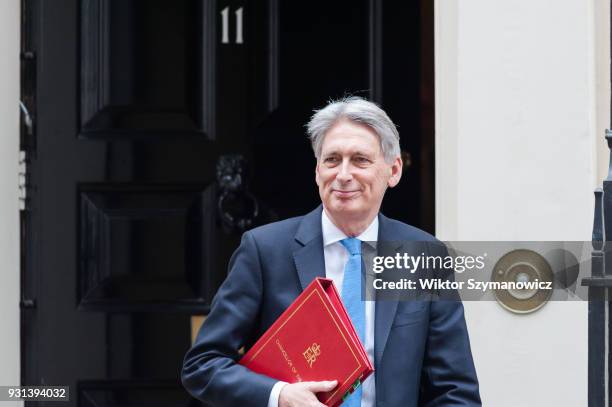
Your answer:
182,97 -> 481,407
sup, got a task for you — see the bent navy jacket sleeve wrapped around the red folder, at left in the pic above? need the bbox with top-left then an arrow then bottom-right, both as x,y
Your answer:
181,232 -> 276,406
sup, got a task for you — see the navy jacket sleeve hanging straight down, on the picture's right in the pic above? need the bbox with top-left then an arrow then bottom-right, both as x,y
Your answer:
419,244 -> 482,407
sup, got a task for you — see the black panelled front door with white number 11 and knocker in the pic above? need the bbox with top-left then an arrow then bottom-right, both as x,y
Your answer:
21,0 -> 433,406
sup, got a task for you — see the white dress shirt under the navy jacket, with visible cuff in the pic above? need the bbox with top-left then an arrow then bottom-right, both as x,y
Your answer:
268,210 -> 378,407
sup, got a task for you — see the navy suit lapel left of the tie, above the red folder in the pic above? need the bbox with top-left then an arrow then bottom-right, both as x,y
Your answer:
293,206 -> 325,290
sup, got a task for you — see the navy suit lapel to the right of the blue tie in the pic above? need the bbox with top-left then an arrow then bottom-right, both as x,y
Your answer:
374,214 -> 399,368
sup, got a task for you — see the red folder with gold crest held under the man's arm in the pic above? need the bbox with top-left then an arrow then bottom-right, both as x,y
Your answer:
240,277 -> 374,407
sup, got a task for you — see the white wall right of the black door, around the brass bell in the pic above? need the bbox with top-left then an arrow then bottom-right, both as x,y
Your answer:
435,0 -> 609,407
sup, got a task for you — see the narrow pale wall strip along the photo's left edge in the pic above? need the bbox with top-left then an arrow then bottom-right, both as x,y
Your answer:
0,0 -> 20,405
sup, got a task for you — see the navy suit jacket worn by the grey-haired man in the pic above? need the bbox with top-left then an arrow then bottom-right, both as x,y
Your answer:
182,206 -> 481,407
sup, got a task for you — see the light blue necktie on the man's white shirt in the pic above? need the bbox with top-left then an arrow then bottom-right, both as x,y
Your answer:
340,237 -> 365,407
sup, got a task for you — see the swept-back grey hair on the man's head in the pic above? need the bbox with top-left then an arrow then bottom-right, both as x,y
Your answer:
306,96 -> 401,163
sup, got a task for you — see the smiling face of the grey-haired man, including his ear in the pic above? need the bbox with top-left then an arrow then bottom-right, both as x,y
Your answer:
316,120 -> 402,226
